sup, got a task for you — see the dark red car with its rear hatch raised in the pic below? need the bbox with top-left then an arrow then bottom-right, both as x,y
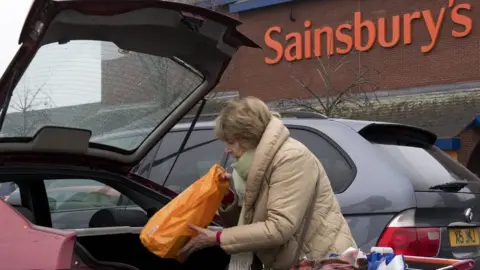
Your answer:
0,0 -> 258,270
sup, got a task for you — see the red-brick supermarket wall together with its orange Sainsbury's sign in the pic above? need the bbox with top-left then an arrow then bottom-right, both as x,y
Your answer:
215,0 -> 480,100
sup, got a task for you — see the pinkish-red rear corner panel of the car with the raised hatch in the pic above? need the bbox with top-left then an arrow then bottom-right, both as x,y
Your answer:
0,201 -> 76,270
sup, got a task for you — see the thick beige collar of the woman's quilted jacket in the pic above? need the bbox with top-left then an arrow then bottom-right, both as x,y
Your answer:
244,117 -> 290,216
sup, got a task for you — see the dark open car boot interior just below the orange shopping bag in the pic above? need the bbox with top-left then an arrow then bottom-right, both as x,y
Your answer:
77,209 -> 229,270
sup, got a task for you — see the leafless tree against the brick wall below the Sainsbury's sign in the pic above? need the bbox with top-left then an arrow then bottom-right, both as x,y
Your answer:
277,55 -> 379,116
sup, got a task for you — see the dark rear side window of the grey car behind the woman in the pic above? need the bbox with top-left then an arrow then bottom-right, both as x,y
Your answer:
290,128 -> 355,193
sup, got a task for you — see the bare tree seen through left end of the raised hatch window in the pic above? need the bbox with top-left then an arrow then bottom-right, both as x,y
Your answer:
9,82 -> 53,137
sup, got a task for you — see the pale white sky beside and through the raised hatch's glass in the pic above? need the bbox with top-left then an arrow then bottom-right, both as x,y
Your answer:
0,0 -> 101,113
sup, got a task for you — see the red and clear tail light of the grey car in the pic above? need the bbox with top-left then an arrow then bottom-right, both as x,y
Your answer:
377,209 -> 441,257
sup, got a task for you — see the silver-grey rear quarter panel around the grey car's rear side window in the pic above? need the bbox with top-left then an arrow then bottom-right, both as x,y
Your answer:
285,120 -> 415,214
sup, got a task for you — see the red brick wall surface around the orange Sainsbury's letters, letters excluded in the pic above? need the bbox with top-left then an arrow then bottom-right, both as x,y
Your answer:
219,0 -> 480,100
